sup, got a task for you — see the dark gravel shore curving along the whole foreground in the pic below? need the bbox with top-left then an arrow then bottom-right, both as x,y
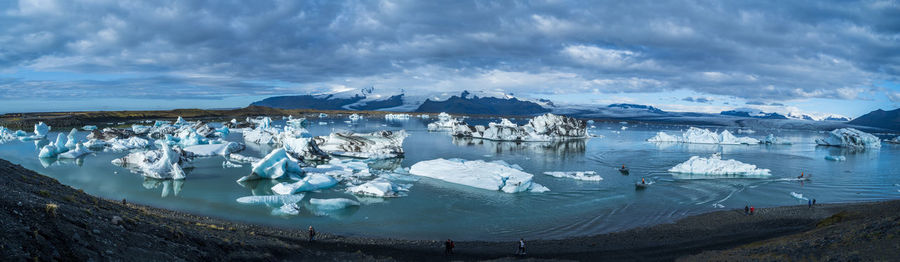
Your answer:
0,159 -> 900,261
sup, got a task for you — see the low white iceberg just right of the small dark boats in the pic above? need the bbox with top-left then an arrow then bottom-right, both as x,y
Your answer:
669,153 -> 771,177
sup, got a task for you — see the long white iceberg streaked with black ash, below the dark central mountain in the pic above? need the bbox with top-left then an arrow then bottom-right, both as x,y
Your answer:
451,113 -> 588,141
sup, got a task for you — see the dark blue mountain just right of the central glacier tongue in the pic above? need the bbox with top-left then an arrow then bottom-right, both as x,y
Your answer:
415,91 -> 550,115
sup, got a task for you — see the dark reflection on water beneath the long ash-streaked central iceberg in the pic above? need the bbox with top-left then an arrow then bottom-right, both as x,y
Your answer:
453,137 -> 586,158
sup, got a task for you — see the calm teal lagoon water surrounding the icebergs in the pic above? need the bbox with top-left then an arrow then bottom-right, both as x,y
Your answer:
0,118 -> 900,240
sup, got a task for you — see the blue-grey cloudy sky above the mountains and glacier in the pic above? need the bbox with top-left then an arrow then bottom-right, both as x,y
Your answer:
0,0 -> 900,117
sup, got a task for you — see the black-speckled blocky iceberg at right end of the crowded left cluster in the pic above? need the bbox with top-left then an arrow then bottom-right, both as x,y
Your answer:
313,130 -> 409,159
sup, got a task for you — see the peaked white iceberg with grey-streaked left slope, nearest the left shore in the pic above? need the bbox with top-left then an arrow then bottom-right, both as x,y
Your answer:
112,143 -> 189,179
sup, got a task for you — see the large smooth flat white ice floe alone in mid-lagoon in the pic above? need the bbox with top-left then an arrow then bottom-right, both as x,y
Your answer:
409,158 -> 543,193
